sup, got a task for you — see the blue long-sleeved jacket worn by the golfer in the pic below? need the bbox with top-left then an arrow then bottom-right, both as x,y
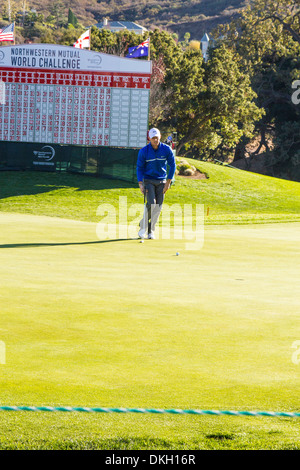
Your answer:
136,142 -> 176,181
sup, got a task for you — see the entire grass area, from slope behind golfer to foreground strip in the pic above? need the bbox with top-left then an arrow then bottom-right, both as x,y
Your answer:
0,163 -> 300,450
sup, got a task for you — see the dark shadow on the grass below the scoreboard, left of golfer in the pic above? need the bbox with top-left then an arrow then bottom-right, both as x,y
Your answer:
0,171 -> 137,199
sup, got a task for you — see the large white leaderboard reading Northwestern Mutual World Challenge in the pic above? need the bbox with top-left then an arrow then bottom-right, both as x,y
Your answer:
0,44 -> 151,147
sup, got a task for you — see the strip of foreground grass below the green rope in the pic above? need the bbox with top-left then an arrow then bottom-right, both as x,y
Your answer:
0,413 -> 299,455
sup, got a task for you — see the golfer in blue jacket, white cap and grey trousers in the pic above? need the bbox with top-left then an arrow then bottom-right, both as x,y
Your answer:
137,128 -> 176,239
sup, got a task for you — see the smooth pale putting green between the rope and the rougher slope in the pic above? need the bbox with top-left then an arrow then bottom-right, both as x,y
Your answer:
0,213 -> 300,411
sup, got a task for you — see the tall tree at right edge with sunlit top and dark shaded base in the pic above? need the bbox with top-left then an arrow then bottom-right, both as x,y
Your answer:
214,0 -> 300,176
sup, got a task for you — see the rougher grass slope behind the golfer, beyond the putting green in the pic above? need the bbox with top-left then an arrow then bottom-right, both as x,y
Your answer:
0,161 -> 300,224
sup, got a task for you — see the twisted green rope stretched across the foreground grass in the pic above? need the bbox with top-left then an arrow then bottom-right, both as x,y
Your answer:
0,406 -> 300,418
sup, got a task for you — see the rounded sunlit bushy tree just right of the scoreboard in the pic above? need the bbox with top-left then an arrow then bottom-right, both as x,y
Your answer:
168,45 -> 262,156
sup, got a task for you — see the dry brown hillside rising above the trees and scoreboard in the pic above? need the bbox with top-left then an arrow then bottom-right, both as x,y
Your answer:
24,0 -> 248,39
